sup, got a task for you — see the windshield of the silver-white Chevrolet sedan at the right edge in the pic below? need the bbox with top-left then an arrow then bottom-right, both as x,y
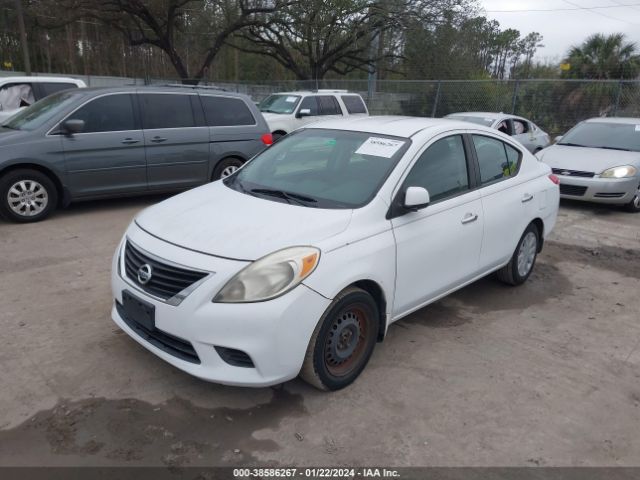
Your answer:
558,122 -> 640,152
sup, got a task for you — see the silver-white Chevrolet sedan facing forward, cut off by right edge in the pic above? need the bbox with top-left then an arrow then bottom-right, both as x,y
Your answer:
537,118 -> 640,213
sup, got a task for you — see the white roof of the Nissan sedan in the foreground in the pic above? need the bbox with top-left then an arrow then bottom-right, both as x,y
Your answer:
304,116 -> 494,138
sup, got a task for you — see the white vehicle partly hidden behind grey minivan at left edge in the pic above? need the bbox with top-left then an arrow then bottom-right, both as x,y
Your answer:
0,77 -> 86,123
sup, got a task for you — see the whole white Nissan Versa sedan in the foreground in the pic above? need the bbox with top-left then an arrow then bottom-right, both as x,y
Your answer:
112,117 -> 559,390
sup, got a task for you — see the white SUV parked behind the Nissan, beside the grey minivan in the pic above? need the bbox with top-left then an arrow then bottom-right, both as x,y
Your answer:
258,90 -> 369,141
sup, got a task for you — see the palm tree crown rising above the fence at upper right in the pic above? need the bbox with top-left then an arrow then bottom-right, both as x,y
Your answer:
564,33 -> 640,80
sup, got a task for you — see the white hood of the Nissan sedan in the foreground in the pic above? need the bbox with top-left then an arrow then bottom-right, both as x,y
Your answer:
136,181 -> 352,260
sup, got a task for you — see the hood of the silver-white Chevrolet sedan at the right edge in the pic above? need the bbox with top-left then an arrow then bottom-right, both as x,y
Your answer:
539,145 -> 640,173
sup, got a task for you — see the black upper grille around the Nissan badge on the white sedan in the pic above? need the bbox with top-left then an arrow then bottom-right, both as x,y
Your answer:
124,242 -> 207,300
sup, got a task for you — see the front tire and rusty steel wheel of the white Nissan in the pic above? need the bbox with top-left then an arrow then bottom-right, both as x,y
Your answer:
300,287 -> 379,390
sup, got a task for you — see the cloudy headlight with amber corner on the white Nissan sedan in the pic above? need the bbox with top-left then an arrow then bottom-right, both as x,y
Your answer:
213,247 -> 320,303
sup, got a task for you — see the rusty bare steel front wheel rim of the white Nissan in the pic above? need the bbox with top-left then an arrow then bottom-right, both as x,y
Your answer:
324,306 -> 370,377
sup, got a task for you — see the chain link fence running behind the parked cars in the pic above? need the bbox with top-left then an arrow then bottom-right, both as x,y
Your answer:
0,72 -> 640,136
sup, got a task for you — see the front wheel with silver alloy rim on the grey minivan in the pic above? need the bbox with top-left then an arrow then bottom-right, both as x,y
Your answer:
0,168 -> 58,223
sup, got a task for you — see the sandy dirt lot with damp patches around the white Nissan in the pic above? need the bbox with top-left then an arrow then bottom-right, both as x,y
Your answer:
0,197 -> 640,466
